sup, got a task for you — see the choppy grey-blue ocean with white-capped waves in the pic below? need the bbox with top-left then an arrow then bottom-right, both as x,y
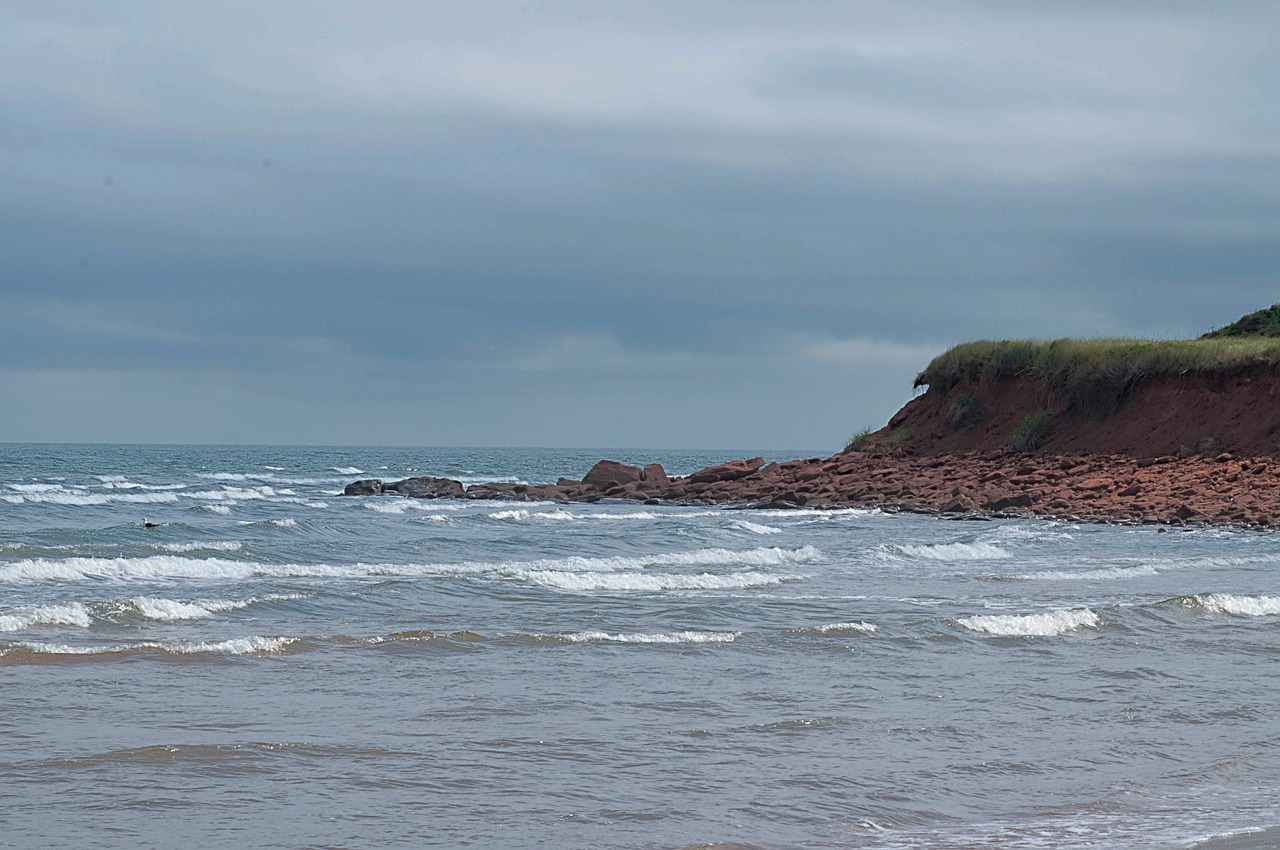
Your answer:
0,444 -> 1280,850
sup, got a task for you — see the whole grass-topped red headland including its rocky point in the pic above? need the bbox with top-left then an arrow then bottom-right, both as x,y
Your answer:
346,305 -> 1280,529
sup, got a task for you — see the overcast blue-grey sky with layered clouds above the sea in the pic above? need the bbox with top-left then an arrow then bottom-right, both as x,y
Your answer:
0,0 -> 1280,452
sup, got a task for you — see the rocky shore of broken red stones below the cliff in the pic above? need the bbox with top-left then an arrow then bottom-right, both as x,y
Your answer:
343,449 -> 1280,530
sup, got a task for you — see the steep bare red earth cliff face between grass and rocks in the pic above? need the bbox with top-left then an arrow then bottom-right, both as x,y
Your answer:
872,367 -> 1280,457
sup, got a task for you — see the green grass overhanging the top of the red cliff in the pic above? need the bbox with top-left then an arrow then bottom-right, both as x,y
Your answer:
915,337 -> 1280,416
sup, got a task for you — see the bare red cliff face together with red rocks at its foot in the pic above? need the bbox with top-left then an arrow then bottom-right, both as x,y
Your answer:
344,367 -> 1280,527
